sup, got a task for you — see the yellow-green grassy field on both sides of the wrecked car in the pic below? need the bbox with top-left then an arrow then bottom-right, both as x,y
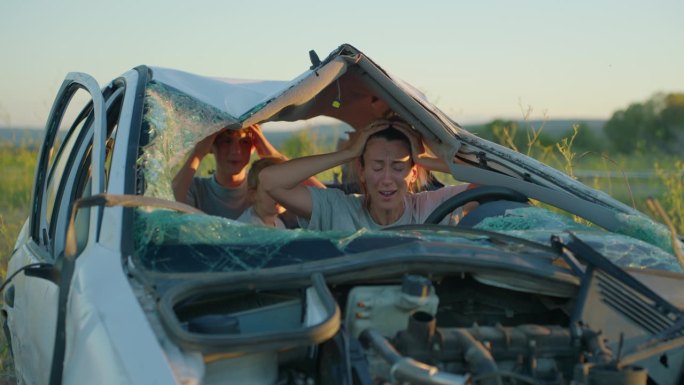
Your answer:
0,130 -> 684,384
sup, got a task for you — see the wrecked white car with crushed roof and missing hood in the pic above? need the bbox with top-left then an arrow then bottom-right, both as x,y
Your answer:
2,45 -> 684,385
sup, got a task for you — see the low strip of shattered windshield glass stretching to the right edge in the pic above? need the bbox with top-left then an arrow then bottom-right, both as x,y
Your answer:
134,208 -> 681,272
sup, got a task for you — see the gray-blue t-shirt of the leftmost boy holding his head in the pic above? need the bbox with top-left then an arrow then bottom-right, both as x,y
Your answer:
188,175 -> 249,219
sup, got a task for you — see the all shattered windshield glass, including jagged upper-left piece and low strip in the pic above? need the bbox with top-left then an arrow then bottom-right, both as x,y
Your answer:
135,81 -> 681,272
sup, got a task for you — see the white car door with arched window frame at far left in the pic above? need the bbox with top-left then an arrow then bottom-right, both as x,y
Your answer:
4,73 -> 106,383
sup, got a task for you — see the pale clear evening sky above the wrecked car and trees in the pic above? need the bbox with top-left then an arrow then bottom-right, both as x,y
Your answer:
0,0 -> 684,127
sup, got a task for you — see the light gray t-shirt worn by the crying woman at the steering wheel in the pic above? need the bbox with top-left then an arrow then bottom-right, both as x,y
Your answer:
299,184 -> 468,231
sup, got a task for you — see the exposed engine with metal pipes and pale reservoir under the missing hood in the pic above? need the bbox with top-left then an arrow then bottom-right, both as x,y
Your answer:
322,275 -> 646,385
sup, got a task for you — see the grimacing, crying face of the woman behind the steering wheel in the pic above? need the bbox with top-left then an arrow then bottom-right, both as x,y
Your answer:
359,138 -> 417,211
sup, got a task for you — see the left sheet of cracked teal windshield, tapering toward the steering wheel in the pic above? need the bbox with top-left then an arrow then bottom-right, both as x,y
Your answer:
135,210 -> 418,272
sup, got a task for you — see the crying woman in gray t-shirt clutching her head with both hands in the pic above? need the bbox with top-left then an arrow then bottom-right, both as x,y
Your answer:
260,120 -> 467,231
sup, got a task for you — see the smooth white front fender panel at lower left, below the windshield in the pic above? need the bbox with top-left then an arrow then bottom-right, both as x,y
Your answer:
64,245 -> 175,384
